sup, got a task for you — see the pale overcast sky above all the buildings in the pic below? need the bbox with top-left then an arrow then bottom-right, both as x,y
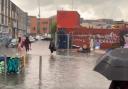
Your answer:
11,0 -> 128,21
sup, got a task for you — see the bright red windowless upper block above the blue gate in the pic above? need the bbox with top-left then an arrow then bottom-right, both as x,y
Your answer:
57,11 -> 80,30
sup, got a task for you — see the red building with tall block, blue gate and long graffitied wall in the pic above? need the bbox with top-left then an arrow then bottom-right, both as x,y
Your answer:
56,11 -> 128,49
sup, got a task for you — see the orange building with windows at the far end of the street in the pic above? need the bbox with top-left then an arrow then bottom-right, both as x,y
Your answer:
28,16 -> 50,35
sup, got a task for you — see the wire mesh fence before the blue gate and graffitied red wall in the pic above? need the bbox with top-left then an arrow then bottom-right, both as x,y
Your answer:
55,32 -> 120,49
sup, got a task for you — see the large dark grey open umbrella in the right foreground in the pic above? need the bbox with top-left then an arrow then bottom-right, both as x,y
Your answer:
94,48 -> 128,81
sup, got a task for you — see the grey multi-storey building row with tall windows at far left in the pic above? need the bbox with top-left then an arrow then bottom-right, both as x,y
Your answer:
0,0 -> 27,38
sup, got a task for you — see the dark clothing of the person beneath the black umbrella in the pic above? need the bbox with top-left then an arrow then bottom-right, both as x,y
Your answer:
109,81 -> 128,89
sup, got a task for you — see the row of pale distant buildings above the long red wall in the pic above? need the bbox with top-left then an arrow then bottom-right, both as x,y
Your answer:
81,19 -> 128,29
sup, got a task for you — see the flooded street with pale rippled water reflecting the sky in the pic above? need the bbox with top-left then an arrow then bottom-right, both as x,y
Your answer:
0,41 -> 110,89
